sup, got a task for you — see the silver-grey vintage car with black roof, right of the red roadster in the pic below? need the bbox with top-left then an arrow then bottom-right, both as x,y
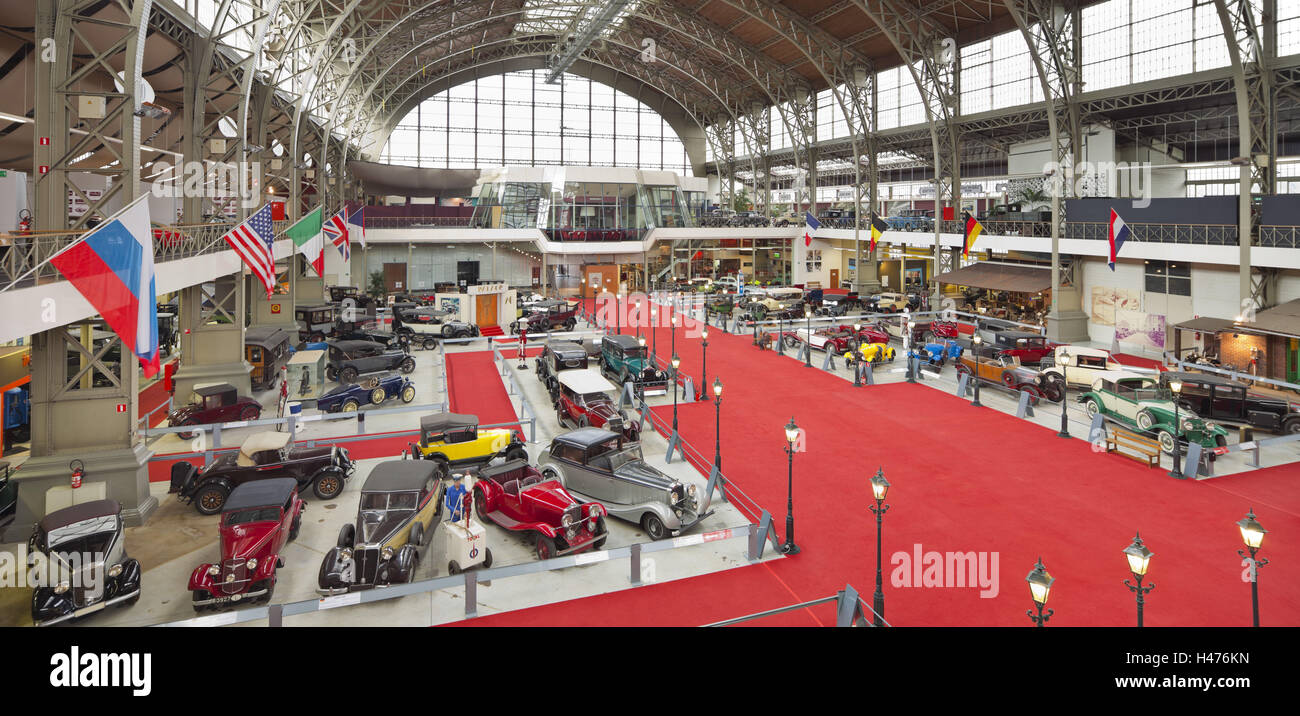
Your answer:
538,428 -> 712,539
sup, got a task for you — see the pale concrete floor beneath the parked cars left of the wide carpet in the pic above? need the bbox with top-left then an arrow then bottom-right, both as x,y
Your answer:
0,322 -> 781,626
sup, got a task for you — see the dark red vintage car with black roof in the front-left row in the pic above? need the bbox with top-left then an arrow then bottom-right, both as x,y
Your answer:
189,477 -> 307,612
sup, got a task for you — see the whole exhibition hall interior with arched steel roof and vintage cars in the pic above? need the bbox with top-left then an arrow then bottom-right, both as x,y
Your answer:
0,0 -> 1300,634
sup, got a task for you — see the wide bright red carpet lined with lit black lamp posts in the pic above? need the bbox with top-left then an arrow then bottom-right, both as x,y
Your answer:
462,297 -> 1300,626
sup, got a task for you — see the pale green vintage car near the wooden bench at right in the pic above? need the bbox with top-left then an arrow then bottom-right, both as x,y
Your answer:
1078,370 -> 1227,454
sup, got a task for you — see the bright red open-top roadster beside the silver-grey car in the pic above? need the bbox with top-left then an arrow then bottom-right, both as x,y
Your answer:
473,460 -> 610,560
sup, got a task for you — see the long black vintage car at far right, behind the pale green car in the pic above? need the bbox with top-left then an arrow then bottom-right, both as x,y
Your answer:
1160,370 -> 1300,434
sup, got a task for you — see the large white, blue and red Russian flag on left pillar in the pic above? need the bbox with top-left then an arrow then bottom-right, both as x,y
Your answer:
49,194 -> 159,378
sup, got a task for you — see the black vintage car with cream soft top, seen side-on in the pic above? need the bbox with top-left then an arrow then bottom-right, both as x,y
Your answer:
168,431 -> 355,515
